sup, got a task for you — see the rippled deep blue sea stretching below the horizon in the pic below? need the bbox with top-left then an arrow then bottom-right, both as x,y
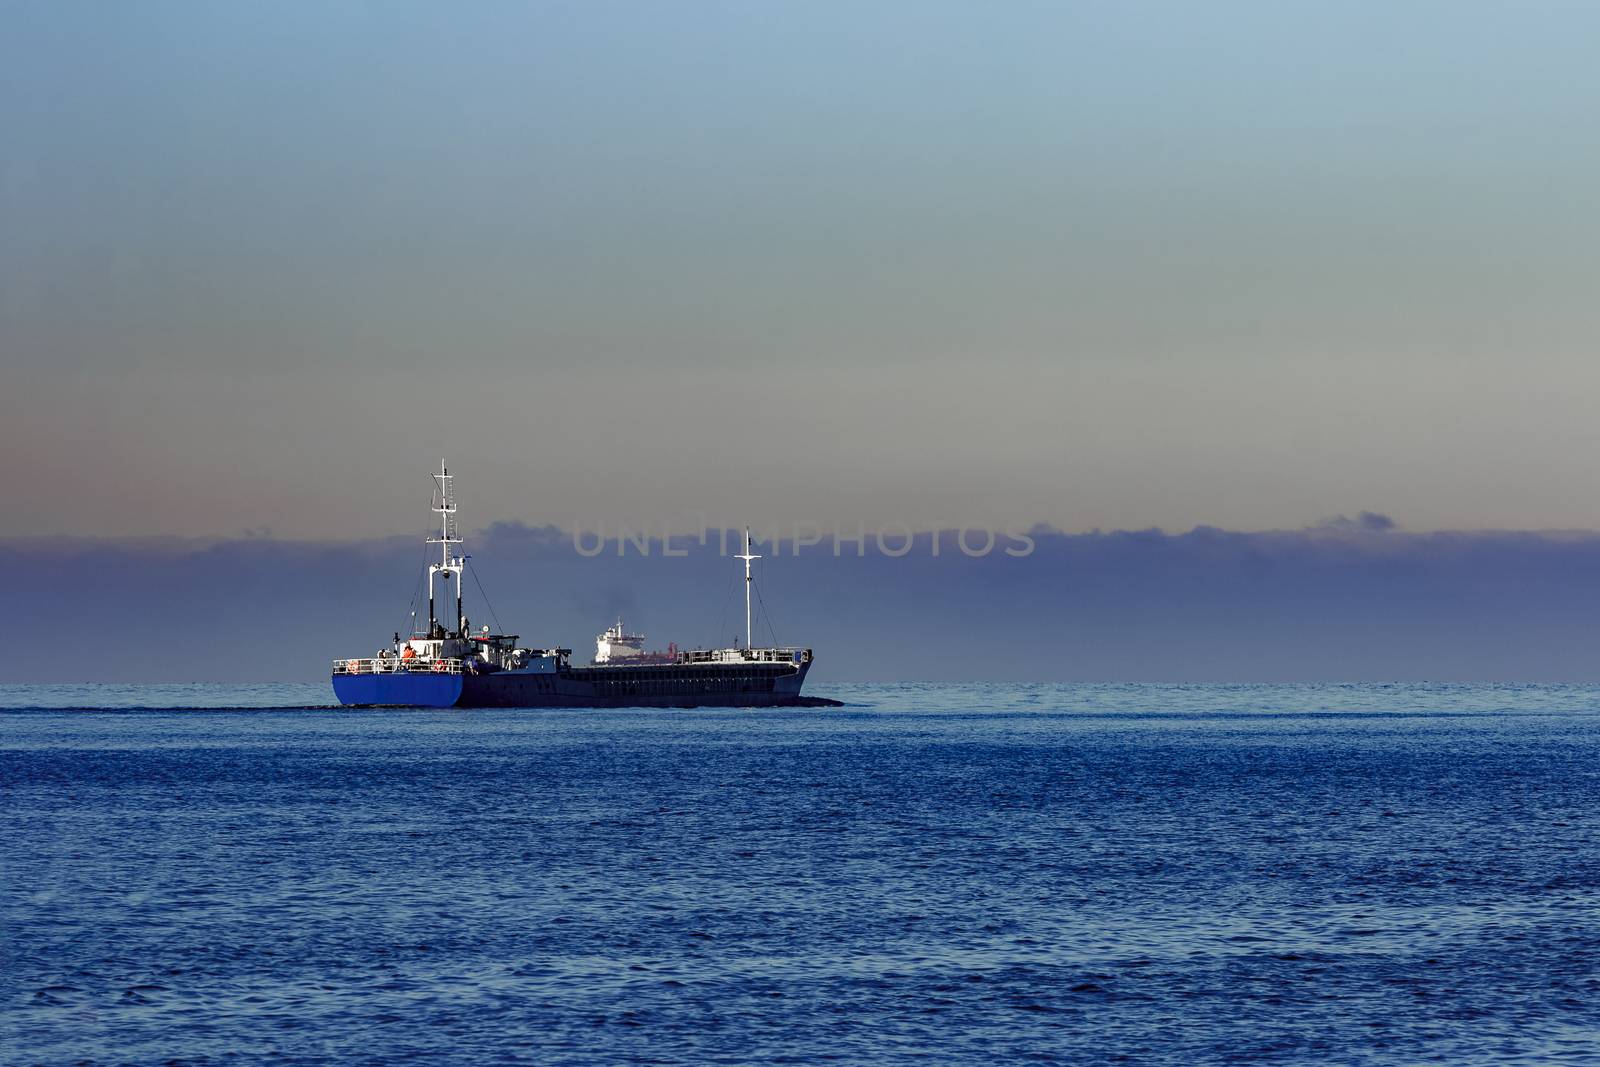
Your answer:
0,685 -> 1600,1065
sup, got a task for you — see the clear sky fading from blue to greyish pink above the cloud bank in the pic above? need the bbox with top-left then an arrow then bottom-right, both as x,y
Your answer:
0,0 -> 1600,534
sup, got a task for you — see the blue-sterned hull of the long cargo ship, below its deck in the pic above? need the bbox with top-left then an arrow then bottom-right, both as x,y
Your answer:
333,661 -> 812,707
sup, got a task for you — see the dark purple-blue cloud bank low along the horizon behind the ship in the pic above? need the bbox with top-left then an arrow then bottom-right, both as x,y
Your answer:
12,524 -> 1600,685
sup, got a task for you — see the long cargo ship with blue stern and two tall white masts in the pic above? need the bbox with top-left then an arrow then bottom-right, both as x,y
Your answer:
333,464 -> 837,707
